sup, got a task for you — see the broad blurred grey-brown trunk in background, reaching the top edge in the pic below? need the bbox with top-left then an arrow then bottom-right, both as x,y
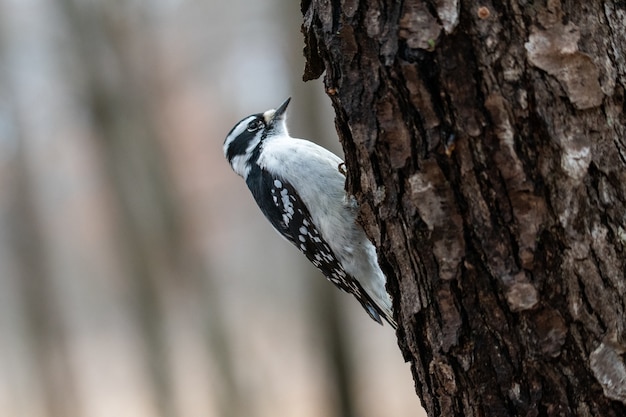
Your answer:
53,0 -> 178,417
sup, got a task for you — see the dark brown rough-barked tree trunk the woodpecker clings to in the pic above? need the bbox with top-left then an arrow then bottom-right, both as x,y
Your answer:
301,0 -> 626,417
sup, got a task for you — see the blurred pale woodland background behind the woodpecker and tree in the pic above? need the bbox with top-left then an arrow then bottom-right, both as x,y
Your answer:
0,0 -> 423,417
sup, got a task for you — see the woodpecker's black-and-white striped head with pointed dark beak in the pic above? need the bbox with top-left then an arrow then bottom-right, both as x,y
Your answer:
224,98 -> 291,178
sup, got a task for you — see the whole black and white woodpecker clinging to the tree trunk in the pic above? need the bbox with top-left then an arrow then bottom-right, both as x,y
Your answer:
224,99 -> 396,328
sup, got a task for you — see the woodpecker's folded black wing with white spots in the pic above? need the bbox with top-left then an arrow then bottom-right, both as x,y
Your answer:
246,167 -> 384,324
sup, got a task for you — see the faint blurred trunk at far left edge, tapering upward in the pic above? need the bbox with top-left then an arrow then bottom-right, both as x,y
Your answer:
12,132 -> 78,417
